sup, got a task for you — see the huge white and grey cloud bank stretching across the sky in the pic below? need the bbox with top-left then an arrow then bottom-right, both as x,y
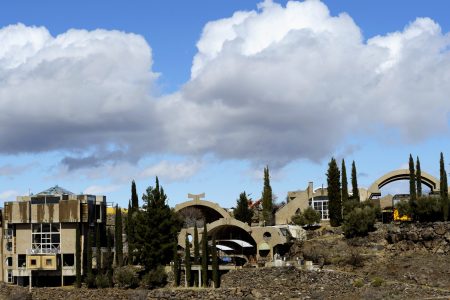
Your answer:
0,0 -> 450,172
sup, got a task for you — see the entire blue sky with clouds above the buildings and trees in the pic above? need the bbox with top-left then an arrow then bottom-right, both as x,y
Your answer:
0,0 -> 450,207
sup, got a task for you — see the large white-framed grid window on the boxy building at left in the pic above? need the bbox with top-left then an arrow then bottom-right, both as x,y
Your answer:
31,223 -> 61,254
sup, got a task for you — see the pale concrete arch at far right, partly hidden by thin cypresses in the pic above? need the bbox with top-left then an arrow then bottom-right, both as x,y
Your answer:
367,169 -> 440,199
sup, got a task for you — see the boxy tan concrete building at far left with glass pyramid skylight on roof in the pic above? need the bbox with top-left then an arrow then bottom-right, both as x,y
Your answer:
0,186 -> 106,286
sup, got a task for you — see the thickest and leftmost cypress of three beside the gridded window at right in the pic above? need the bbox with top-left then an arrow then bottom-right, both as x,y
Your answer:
327,158 -> 342,227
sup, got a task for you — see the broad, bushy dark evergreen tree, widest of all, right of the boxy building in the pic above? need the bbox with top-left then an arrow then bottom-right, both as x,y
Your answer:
134,177 -> 181,271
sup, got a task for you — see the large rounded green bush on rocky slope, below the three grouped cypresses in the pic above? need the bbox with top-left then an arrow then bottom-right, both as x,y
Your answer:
342,202 -> 377,238
